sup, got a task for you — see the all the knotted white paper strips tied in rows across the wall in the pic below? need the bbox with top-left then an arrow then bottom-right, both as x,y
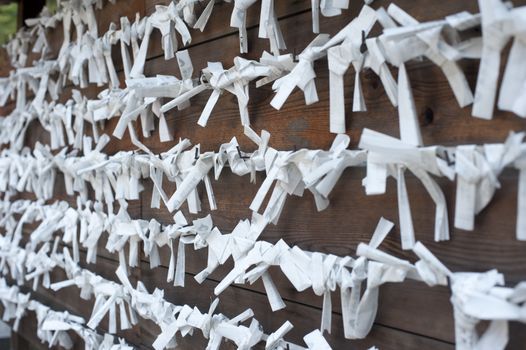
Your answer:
0,0 -> 526,350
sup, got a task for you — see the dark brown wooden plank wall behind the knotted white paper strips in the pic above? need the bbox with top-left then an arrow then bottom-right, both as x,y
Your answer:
3,0 -> 526,349
